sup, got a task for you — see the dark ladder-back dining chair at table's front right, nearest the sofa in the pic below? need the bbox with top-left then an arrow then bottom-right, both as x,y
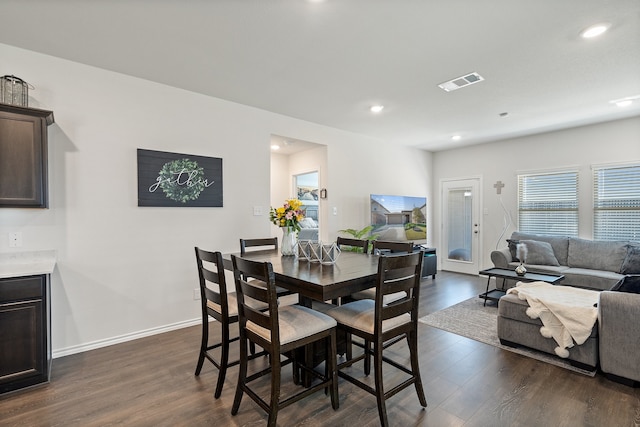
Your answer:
327,252 -> 427,426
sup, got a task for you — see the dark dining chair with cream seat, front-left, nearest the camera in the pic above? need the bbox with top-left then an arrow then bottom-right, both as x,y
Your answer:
231,255 -> 339,426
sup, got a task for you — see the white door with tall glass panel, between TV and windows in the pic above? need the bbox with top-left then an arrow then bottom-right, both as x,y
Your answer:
440,178 -> 481,274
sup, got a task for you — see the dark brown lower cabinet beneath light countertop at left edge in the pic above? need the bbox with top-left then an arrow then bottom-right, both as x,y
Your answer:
0,275 -> 51,393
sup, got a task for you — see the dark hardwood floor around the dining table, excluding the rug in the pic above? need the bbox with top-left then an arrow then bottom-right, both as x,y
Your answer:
0,272 -> 640,427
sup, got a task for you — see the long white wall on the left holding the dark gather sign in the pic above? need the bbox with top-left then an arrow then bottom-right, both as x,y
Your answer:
0,44 -> 431,356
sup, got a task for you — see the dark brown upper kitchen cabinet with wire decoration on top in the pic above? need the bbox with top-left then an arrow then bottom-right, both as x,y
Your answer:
0,103 -> 53,208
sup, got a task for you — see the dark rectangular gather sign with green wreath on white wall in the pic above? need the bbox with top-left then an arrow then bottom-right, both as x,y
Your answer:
138,148 -> 222,207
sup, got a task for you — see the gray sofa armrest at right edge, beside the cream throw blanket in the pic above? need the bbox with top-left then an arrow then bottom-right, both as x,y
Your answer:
598,291 -> 640,381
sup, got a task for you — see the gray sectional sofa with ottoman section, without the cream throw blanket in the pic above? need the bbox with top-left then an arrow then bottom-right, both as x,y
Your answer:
491,232 -> 640,385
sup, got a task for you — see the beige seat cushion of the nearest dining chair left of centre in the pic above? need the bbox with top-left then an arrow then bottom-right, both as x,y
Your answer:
247,305 -> 336,345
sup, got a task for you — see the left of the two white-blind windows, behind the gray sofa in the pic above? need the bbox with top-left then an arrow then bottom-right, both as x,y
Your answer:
518,171 -> 578,237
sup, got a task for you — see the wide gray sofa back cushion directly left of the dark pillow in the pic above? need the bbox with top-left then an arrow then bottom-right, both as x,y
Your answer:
567,237 -> 628,272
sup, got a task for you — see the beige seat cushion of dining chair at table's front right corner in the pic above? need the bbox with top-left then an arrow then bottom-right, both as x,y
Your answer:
327,299 -> 411,334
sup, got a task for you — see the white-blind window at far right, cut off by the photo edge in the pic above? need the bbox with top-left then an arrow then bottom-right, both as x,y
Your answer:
593,164 -> 640,241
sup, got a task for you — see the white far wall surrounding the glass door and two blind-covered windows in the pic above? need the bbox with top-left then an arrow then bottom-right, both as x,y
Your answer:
433,117 -> 640,267
